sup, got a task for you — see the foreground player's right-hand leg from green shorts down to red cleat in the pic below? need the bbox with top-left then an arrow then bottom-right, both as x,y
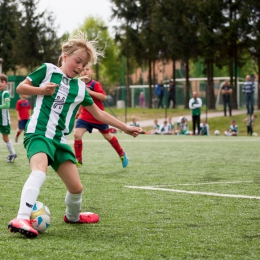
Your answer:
57,160 -> 99,224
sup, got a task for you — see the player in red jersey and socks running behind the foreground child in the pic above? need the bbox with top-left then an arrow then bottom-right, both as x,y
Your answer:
74,64 -> 128,168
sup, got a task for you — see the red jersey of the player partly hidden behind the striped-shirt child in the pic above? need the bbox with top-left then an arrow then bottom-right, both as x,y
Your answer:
79,80 -> 106,124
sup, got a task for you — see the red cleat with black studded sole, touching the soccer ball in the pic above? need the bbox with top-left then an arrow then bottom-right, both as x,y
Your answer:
8,218 -> 38,238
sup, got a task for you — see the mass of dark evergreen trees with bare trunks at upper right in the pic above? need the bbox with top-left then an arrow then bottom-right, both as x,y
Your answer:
111,0 -> 260,109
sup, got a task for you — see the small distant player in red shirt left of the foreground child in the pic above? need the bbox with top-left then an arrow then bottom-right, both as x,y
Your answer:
15,95 -> 31,143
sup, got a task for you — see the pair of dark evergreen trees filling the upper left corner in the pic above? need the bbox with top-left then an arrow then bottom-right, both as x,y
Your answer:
0,0 -> 60,73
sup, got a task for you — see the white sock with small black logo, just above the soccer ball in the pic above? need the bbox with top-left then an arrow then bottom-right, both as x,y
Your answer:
17,171 -> 46,219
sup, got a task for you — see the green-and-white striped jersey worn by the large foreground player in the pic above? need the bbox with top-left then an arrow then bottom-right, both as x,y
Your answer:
25,63 -> 93,143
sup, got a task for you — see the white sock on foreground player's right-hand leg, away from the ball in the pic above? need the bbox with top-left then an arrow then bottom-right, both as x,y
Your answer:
65,191 -> 82,222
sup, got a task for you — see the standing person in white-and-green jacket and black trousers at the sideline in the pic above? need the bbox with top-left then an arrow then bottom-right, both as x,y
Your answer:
189,91 -> 202,135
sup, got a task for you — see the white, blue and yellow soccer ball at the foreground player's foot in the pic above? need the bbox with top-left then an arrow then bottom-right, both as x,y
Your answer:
31,201 -> 51,232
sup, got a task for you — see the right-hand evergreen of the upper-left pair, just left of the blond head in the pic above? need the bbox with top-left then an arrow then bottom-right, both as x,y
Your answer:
16,0 -> 60,71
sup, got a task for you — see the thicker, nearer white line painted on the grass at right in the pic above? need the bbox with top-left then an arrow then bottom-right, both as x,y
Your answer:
125,186 -> 260,200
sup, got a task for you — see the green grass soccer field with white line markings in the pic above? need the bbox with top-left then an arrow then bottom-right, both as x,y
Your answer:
0,133 -> 260,260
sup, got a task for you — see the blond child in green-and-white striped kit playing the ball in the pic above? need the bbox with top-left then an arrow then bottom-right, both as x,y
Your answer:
8,32 -> 141,237
